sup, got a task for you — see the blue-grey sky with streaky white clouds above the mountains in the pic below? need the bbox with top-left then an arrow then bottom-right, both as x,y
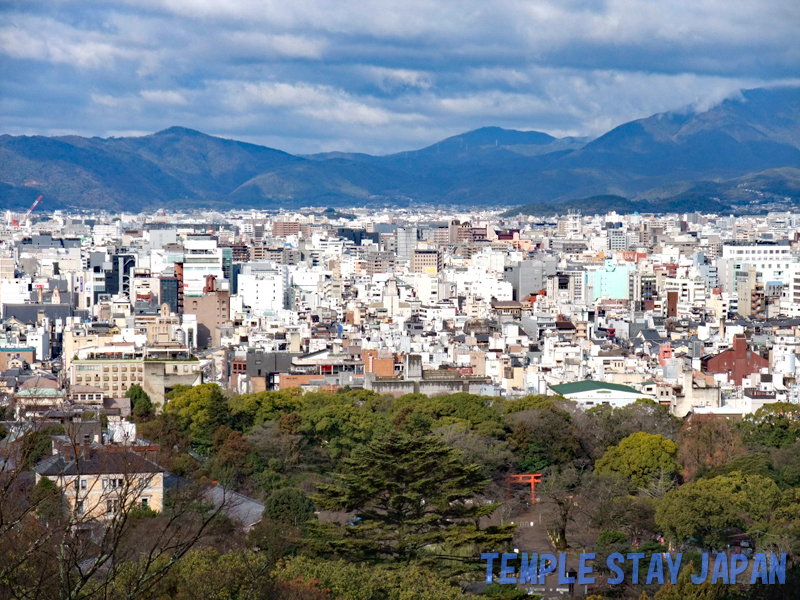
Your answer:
0,0 -> 800,153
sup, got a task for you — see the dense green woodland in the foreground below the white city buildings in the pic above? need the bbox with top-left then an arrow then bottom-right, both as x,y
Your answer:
0,384 -> 800,600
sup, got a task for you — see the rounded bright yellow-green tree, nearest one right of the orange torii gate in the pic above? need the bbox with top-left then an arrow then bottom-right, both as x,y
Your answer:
595,431 -> 678,489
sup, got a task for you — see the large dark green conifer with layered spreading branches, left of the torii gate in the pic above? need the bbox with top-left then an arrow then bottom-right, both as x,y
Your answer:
314,431 -> 514,566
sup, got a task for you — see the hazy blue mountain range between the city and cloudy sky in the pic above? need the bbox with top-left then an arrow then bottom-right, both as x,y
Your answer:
0,87 -> 800,213
